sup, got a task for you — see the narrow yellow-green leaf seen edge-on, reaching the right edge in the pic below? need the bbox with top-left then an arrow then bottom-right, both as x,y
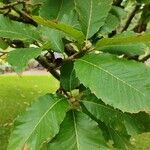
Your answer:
96,33 -> 150,49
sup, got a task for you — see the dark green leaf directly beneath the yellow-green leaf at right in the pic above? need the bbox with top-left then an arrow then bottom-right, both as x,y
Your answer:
98,43 -> 148,56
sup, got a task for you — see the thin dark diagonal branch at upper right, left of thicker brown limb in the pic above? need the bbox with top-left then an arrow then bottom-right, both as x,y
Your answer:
121,4 -> 141,32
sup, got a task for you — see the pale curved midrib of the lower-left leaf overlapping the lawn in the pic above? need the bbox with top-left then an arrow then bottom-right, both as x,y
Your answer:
21,99 -> 62,148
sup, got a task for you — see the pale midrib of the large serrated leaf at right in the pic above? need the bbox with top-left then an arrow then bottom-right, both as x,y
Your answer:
79,59 -> 145,97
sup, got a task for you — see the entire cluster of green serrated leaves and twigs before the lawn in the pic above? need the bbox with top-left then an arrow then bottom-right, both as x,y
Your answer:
0,0 -> 150,150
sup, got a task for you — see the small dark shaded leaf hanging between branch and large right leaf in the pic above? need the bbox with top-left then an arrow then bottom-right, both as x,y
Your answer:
60,62 -> 79,91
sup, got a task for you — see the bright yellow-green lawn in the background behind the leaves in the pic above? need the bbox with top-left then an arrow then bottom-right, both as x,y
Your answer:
0,76 -> 150,150
